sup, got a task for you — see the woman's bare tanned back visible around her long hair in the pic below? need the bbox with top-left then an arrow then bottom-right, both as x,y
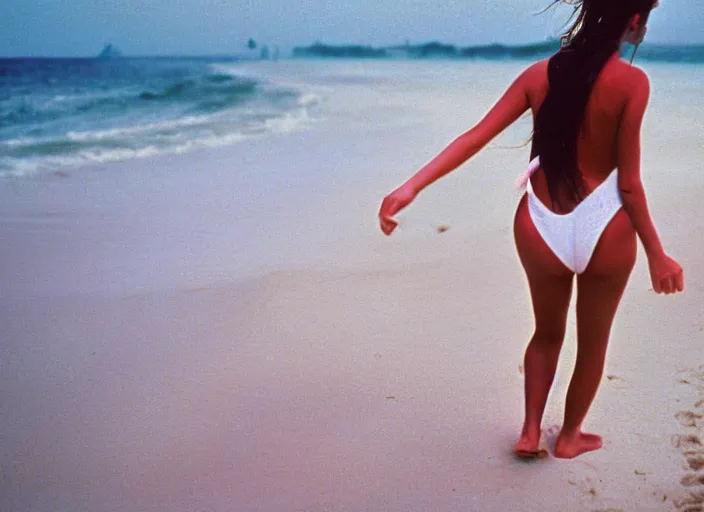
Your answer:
527,54 -> 636,213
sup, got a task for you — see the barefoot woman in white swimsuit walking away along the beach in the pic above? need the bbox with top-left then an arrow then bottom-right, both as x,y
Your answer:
379,0 -> 684,458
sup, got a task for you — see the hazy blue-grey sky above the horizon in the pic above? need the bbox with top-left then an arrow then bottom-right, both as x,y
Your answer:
0,0 -> 704,57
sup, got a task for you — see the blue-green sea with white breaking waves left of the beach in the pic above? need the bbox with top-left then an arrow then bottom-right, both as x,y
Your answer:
0,58 -> 318,177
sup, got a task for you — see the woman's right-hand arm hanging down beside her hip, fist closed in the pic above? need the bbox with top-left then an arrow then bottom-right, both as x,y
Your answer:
618,68 -> 684,293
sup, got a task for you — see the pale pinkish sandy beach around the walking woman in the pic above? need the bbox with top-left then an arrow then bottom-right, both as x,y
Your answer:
0,61 -> 704,512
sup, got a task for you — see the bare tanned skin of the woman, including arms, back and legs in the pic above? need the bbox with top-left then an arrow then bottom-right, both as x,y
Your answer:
379,11 -> 684,458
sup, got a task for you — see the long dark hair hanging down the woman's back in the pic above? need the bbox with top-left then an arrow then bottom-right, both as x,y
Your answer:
531,0 -> 656,207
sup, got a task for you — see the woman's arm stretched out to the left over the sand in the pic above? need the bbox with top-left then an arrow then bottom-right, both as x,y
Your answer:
379,63 -> 540,235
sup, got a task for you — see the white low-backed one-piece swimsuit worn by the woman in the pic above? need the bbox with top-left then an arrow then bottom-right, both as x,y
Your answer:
518,157 -> 623,274
